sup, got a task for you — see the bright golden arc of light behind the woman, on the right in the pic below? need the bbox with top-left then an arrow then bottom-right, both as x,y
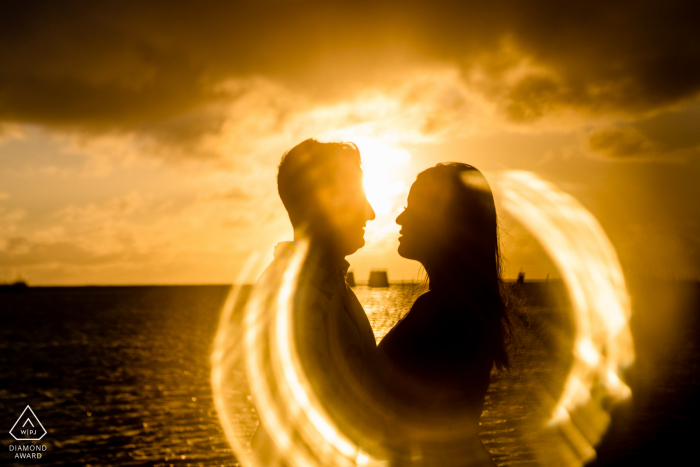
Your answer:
496,171 -> 634,463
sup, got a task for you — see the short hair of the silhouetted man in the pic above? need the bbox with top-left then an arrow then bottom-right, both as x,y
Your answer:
277,139 -> 362,228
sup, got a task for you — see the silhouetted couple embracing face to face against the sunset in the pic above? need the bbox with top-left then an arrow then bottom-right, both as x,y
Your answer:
252,139 -> 510,466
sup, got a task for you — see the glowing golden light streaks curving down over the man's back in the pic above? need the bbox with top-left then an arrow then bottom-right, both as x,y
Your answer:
212,242 -> 377,466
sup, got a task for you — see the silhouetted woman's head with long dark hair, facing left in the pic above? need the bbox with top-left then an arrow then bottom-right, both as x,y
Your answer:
396,162 -> 510,369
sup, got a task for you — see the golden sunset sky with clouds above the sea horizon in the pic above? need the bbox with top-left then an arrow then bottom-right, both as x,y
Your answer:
0,0 -> 700,285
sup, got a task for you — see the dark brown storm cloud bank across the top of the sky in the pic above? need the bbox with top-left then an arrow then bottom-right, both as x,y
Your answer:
0,0 -> 700,135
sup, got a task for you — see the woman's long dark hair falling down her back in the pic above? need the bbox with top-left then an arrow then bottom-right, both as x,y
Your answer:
414,162 -> 512,370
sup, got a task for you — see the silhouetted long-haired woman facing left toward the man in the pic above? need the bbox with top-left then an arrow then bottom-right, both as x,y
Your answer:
376,163 -> 510,466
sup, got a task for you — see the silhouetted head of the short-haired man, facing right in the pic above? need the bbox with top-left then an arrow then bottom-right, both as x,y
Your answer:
277,139 -> 374,256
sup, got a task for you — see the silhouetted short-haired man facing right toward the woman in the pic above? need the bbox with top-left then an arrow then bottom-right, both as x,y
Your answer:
252,139 -> 376,465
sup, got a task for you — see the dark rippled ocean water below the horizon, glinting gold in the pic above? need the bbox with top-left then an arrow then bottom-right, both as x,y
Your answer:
0,281 -> 700,466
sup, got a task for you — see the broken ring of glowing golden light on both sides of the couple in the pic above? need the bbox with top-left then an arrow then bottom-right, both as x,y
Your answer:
211,172 -> 634,467
